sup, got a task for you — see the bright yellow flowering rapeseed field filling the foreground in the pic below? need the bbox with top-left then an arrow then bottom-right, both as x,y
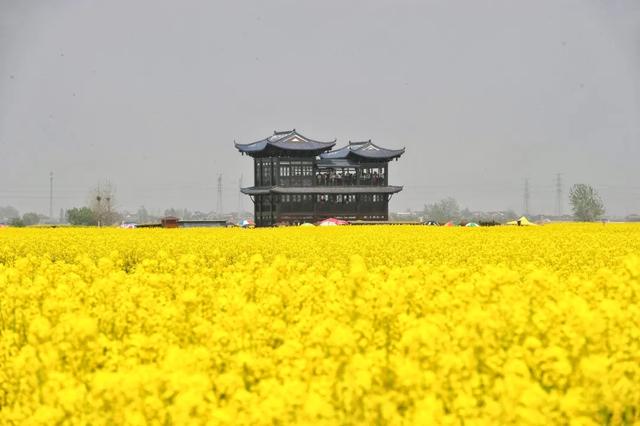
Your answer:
0,224 -> 640,425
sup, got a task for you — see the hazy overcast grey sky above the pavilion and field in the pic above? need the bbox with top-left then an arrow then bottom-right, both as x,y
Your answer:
0,0 -> 640,218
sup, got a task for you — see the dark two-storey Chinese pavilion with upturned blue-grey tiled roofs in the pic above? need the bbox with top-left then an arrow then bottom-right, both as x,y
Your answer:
235,129 -> 404,226
